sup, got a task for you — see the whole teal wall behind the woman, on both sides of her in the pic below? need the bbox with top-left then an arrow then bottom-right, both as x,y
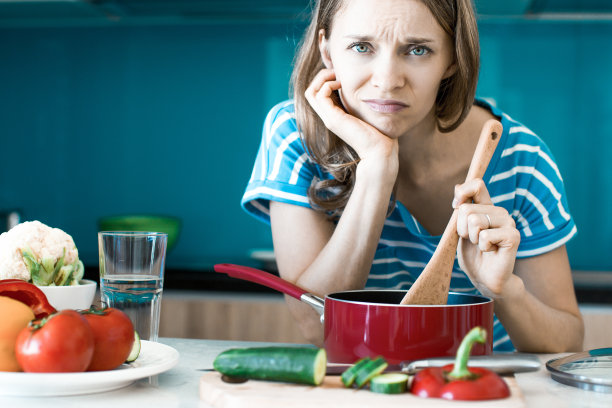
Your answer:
0,20 -> 612,270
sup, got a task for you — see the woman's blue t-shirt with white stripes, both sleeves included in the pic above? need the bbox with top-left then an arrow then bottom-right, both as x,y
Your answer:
242,100 -> 576,351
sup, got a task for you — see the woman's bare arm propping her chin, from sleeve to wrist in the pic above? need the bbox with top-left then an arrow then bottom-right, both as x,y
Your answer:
271,153 -> 397,345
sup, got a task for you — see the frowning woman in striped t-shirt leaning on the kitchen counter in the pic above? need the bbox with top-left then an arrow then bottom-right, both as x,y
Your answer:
242,0 -> 584,352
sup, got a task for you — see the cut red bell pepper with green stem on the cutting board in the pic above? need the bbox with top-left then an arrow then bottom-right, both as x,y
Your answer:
411,327 -> 510,400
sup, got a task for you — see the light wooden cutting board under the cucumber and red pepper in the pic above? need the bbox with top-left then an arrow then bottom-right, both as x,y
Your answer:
200,372 -> 526,408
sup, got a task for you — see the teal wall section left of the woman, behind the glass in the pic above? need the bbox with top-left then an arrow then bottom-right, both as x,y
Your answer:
0,25 -> 302,267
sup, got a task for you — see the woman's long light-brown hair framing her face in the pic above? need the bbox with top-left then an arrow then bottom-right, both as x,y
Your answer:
291,0 -> 480,217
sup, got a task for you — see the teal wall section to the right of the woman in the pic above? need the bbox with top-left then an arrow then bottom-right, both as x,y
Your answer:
478,20 -> 612,271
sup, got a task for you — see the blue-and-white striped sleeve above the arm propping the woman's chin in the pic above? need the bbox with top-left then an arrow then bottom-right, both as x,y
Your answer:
241,101 -> 317,223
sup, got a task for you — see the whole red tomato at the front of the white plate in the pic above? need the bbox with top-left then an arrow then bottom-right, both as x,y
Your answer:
15,310 -> 94,373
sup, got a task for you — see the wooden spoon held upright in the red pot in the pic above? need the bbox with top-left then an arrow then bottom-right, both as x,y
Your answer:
400,119 -> 503,305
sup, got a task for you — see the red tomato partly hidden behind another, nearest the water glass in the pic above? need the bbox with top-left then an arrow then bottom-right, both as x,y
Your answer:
81,307 -> 134,371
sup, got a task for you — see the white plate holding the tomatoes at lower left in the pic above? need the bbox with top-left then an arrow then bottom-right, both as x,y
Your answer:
0,340 -> 179,397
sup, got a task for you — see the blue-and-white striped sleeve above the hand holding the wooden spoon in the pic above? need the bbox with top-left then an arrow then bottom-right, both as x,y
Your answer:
488,117 -> 577,258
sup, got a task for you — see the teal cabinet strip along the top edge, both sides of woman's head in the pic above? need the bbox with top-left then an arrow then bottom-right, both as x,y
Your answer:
0,0 -> 612,27
